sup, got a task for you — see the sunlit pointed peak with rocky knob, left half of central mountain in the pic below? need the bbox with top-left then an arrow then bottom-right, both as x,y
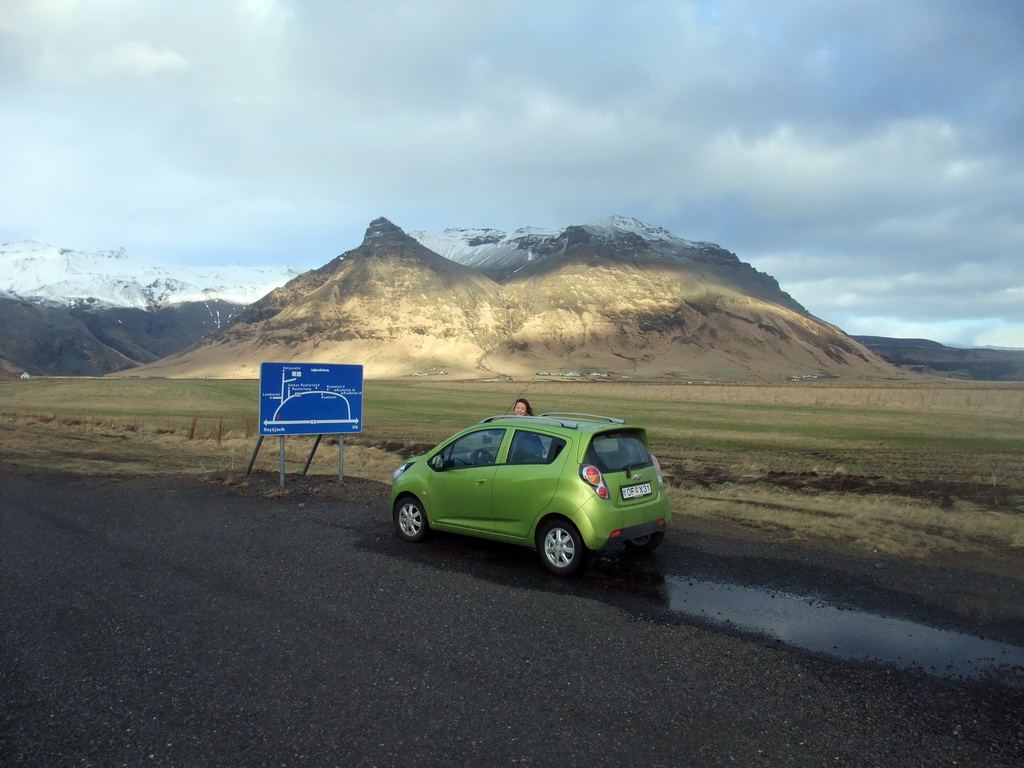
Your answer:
124,219 -> 503,377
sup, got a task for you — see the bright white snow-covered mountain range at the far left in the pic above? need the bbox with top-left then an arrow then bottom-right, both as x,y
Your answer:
0,241 -> 299,309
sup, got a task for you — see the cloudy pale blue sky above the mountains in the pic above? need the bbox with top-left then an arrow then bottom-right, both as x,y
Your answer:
0,0 -> 1024,348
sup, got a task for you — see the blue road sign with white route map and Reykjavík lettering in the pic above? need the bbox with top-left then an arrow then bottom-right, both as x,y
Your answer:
259,362 -> 362,435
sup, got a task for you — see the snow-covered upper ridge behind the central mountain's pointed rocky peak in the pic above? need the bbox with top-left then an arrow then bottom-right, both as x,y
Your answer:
409,216 -> 732,280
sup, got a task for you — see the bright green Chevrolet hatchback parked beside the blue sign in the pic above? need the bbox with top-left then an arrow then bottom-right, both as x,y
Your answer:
391,414 -> 672,575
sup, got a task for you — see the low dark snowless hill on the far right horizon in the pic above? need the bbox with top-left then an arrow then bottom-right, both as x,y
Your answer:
853,336 -> 1024,381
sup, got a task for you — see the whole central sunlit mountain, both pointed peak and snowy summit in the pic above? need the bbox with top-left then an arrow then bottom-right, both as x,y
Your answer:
125,217 -> 906,380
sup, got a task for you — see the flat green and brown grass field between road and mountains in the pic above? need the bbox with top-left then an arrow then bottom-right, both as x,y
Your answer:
0,378 -> 1024,571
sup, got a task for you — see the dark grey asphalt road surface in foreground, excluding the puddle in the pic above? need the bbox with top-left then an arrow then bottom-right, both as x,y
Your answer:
0,468 -> 1024,768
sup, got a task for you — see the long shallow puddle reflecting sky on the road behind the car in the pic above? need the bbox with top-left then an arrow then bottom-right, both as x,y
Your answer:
665,578 -> 1024,686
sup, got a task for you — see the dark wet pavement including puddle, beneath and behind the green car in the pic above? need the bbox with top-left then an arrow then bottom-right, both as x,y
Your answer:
389,520 -> 1024,688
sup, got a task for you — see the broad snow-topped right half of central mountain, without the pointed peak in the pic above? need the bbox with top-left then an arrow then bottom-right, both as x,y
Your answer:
419,216 -> 892,379
